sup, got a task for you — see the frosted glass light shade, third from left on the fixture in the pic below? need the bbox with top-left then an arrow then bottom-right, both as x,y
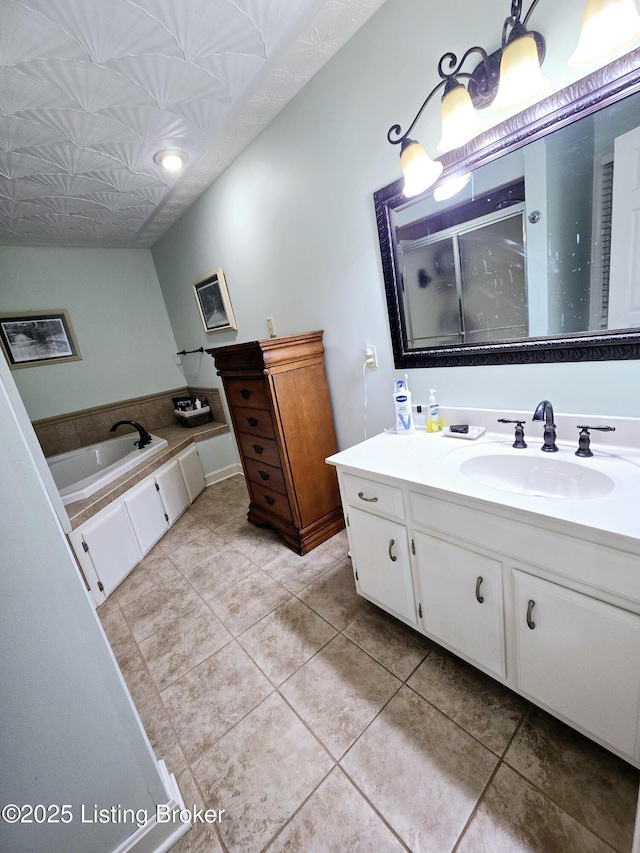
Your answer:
491,33 -> 549,110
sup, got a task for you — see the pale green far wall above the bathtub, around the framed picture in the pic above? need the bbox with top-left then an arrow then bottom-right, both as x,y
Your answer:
0,247 -> 185,420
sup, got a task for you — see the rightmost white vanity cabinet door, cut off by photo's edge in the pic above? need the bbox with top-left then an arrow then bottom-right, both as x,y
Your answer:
513,569 -> 640,758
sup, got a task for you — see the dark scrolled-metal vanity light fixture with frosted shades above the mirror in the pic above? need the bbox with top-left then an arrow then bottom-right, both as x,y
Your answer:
387,0 -> 640,197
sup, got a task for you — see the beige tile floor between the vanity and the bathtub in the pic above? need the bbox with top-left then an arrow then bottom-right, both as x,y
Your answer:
99,477 -> 640,853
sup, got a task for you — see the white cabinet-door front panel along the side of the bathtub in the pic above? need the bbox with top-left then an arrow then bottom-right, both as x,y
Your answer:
69,445 -> 205,604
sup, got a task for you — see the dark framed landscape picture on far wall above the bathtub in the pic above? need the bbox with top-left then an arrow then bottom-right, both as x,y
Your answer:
0,311 -> 82,369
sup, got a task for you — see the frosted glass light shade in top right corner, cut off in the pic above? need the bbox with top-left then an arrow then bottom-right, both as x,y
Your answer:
569,0 -> 640,67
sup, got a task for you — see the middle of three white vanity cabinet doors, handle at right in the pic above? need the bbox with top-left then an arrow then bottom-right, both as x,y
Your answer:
415,532 -> 506,678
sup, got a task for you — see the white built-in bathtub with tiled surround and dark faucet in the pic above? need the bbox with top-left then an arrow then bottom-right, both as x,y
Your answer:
47,432 -> 167,504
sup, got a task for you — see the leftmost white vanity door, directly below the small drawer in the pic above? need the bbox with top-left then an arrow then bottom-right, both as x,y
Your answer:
348,507 -> 418,627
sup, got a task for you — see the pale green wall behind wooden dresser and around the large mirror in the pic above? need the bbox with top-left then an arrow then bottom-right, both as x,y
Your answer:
152,0 -> 640,447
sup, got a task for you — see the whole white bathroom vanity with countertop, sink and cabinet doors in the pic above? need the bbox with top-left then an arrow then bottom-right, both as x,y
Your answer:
327,412 -> 640,767
